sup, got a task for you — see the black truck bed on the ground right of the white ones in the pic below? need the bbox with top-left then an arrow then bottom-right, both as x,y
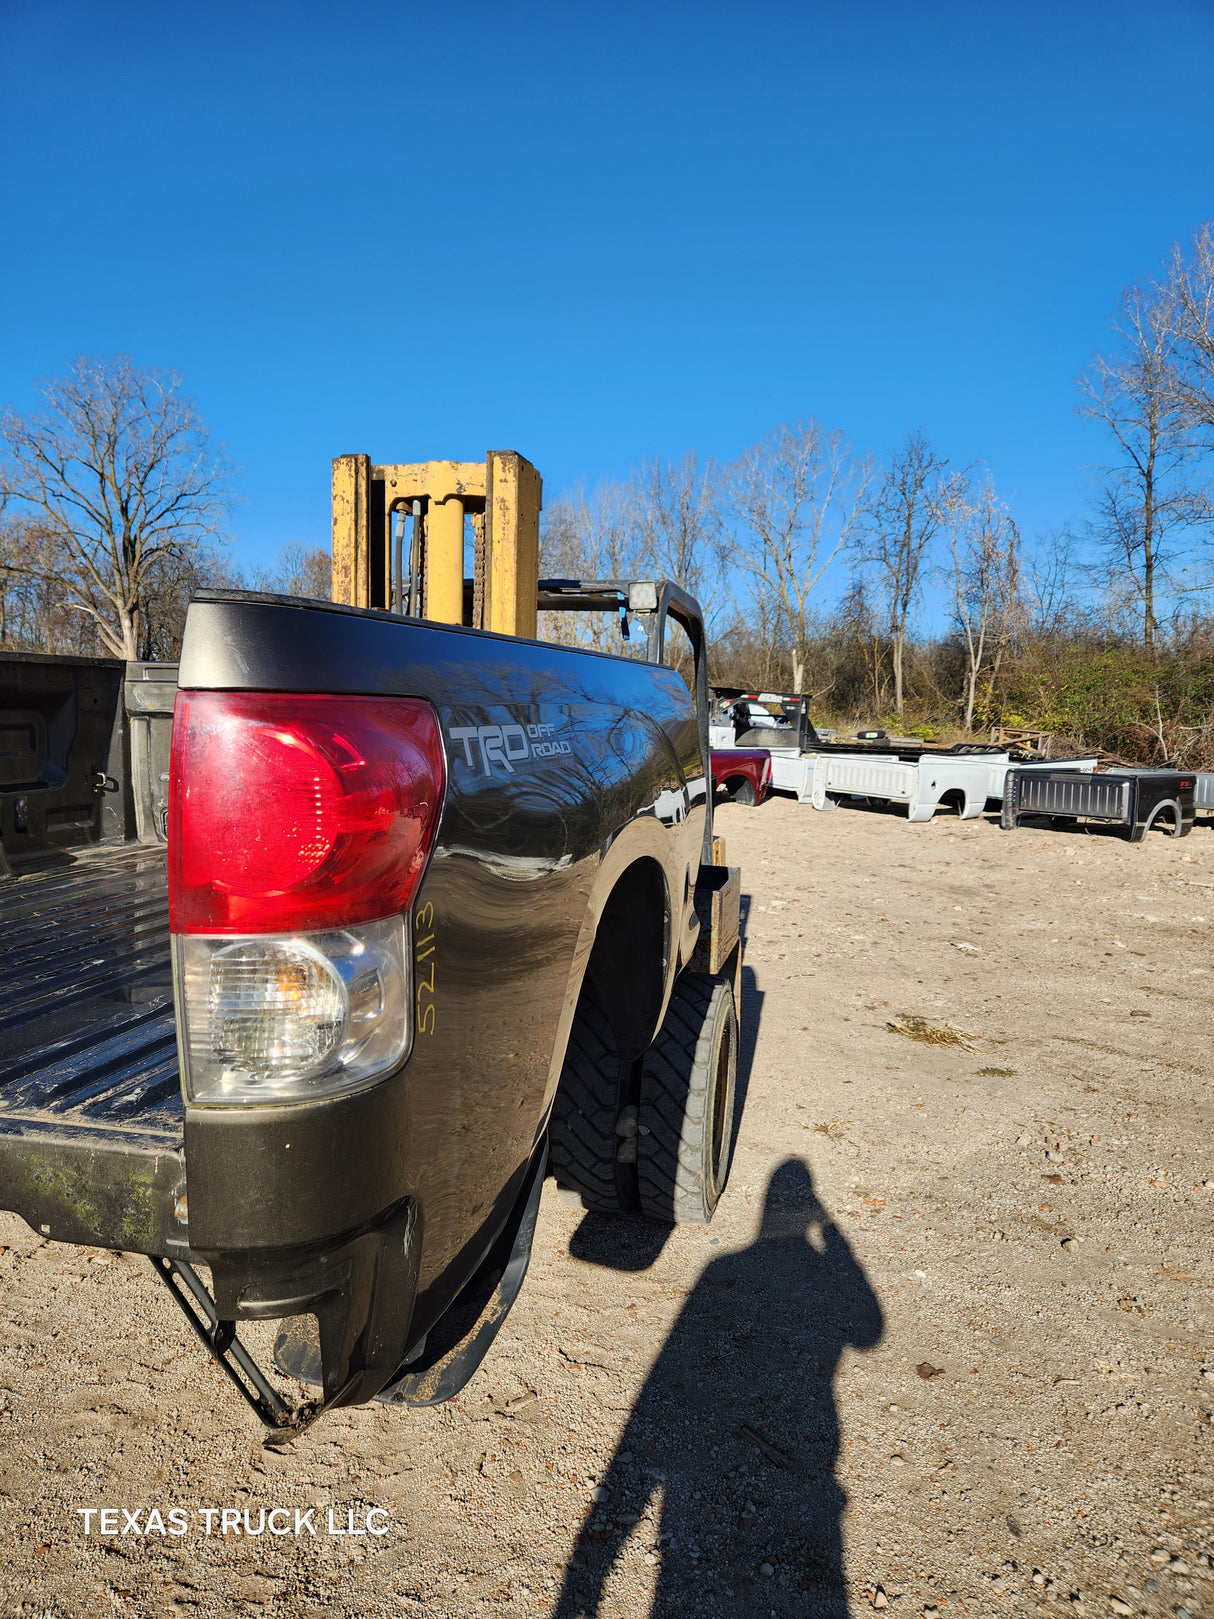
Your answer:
1000,767 -> 1196,843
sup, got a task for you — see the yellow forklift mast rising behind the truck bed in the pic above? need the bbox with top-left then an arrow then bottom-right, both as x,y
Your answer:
333,450 -> 542,640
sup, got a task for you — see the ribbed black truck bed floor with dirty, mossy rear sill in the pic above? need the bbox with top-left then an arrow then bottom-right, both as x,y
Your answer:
0,845 -> 188,1255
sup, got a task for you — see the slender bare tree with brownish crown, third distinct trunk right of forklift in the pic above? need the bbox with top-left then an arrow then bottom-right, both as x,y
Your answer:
944,479 -> 1020,735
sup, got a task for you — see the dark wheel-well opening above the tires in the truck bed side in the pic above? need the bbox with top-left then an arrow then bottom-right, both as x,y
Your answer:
584,860 -> 670,1059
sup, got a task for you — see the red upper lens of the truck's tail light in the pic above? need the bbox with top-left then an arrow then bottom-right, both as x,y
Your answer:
168,691 -> 445,934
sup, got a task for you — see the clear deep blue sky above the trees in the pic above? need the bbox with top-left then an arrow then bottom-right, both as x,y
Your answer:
0,0 -> 1214,582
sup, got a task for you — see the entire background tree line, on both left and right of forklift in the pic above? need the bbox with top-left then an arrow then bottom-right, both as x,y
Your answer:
0,223 -> 1214,763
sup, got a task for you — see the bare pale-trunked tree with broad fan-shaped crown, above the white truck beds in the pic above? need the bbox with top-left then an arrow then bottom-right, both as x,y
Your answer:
728,418 -> 871,691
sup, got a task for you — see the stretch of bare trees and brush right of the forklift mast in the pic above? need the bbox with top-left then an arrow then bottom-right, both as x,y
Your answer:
544,223 -> 1214,766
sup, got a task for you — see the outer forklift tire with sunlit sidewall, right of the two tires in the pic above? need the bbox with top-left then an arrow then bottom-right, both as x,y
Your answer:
636,973 -> 738,1226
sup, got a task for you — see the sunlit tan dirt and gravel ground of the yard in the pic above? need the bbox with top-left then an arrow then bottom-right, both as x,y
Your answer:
0,800 -> 1214,1619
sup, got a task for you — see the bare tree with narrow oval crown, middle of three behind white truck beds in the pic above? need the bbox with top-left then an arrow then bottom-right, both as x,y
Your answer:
863,429 -> 949,719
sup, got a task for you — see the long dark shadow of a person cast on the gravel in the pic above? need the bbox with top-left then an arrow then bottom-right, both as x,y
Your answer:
555,1159 -> 882,1619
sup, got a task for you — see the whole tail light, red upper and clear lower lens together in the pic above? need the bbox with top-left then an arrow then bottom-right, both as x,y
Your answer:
168,691 -> 445,1104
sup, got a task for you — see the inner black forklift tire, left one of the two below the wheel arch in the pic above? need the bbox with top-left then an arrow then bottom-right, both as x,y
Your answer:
549,991 -> 636,1214
